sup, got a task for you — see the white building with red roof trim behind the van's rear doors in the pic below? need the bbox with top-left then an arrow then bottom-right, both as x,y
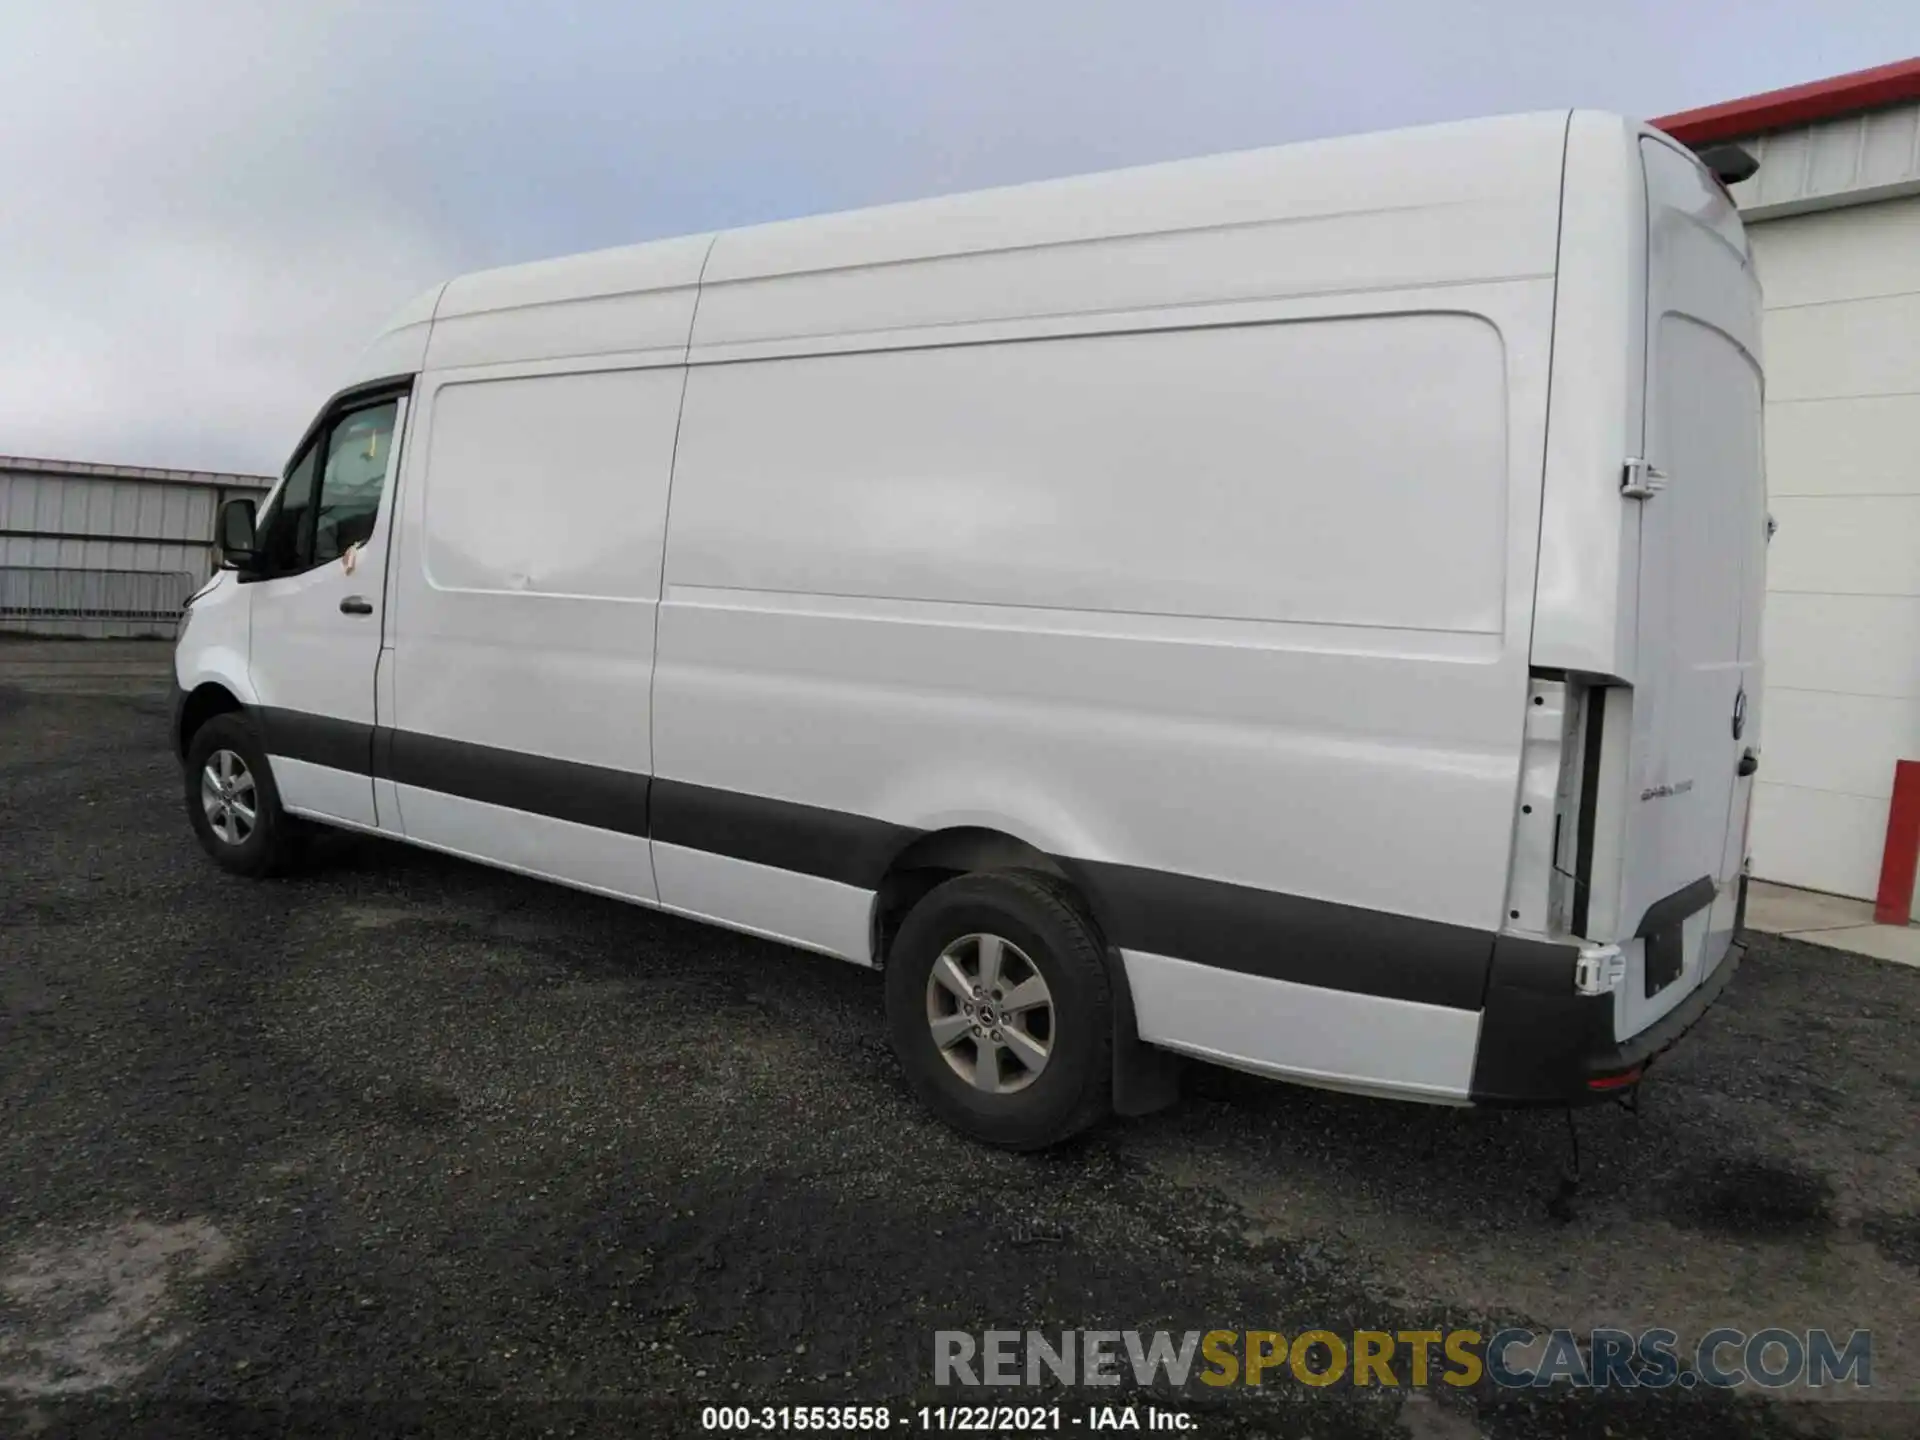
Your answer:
1653,58 -> 1920,920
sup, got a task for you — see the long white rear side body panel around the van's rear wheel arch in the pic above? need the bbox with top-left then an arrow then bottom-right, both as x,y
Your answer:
653,282 -> 1549,1098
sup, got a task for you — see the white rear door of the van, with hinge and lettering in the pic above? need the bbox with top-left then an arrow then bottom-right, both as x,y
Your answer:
1615,136 -> 1766,1039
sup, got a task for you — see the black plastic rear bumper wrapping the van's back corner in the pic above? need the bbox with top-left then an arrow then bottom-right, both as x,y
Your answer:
1469,913 -> 1745,1106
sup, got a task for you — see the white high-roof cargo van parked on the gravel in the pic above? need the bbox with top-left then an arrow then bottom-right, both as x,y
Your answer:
175,111 -> 1764,1146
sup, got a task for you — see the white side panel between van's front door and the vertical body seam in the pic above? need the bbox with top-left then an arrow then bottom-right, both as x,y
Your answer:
374,365 -> 685,899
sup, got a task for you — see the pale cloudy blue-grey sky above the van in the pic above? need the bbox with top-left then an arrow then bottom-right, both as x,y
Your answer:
0,0 -> 1920,472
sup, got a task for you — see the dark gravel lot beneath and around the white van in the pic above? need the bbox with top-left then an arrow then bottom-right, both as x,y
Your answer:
0,643 -> 1920,1438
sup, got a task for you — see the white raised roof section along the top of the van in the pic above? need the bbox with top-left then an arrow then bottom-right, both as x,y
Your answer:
353,111 -> 1644,378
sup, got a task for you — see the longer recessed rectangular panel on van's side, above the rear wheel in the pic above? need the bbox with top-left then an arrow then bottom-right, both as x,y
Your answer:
668,313 -> 1507,637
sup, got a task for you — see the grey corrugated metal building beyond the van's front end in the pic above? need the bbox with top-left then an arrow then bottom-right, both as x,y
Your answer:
0,455 -> 273,637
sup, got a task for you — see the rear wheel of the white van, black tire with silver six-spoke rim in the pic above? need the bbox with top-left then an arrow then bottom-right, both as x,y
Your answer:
887,870 -> 1114,1150
